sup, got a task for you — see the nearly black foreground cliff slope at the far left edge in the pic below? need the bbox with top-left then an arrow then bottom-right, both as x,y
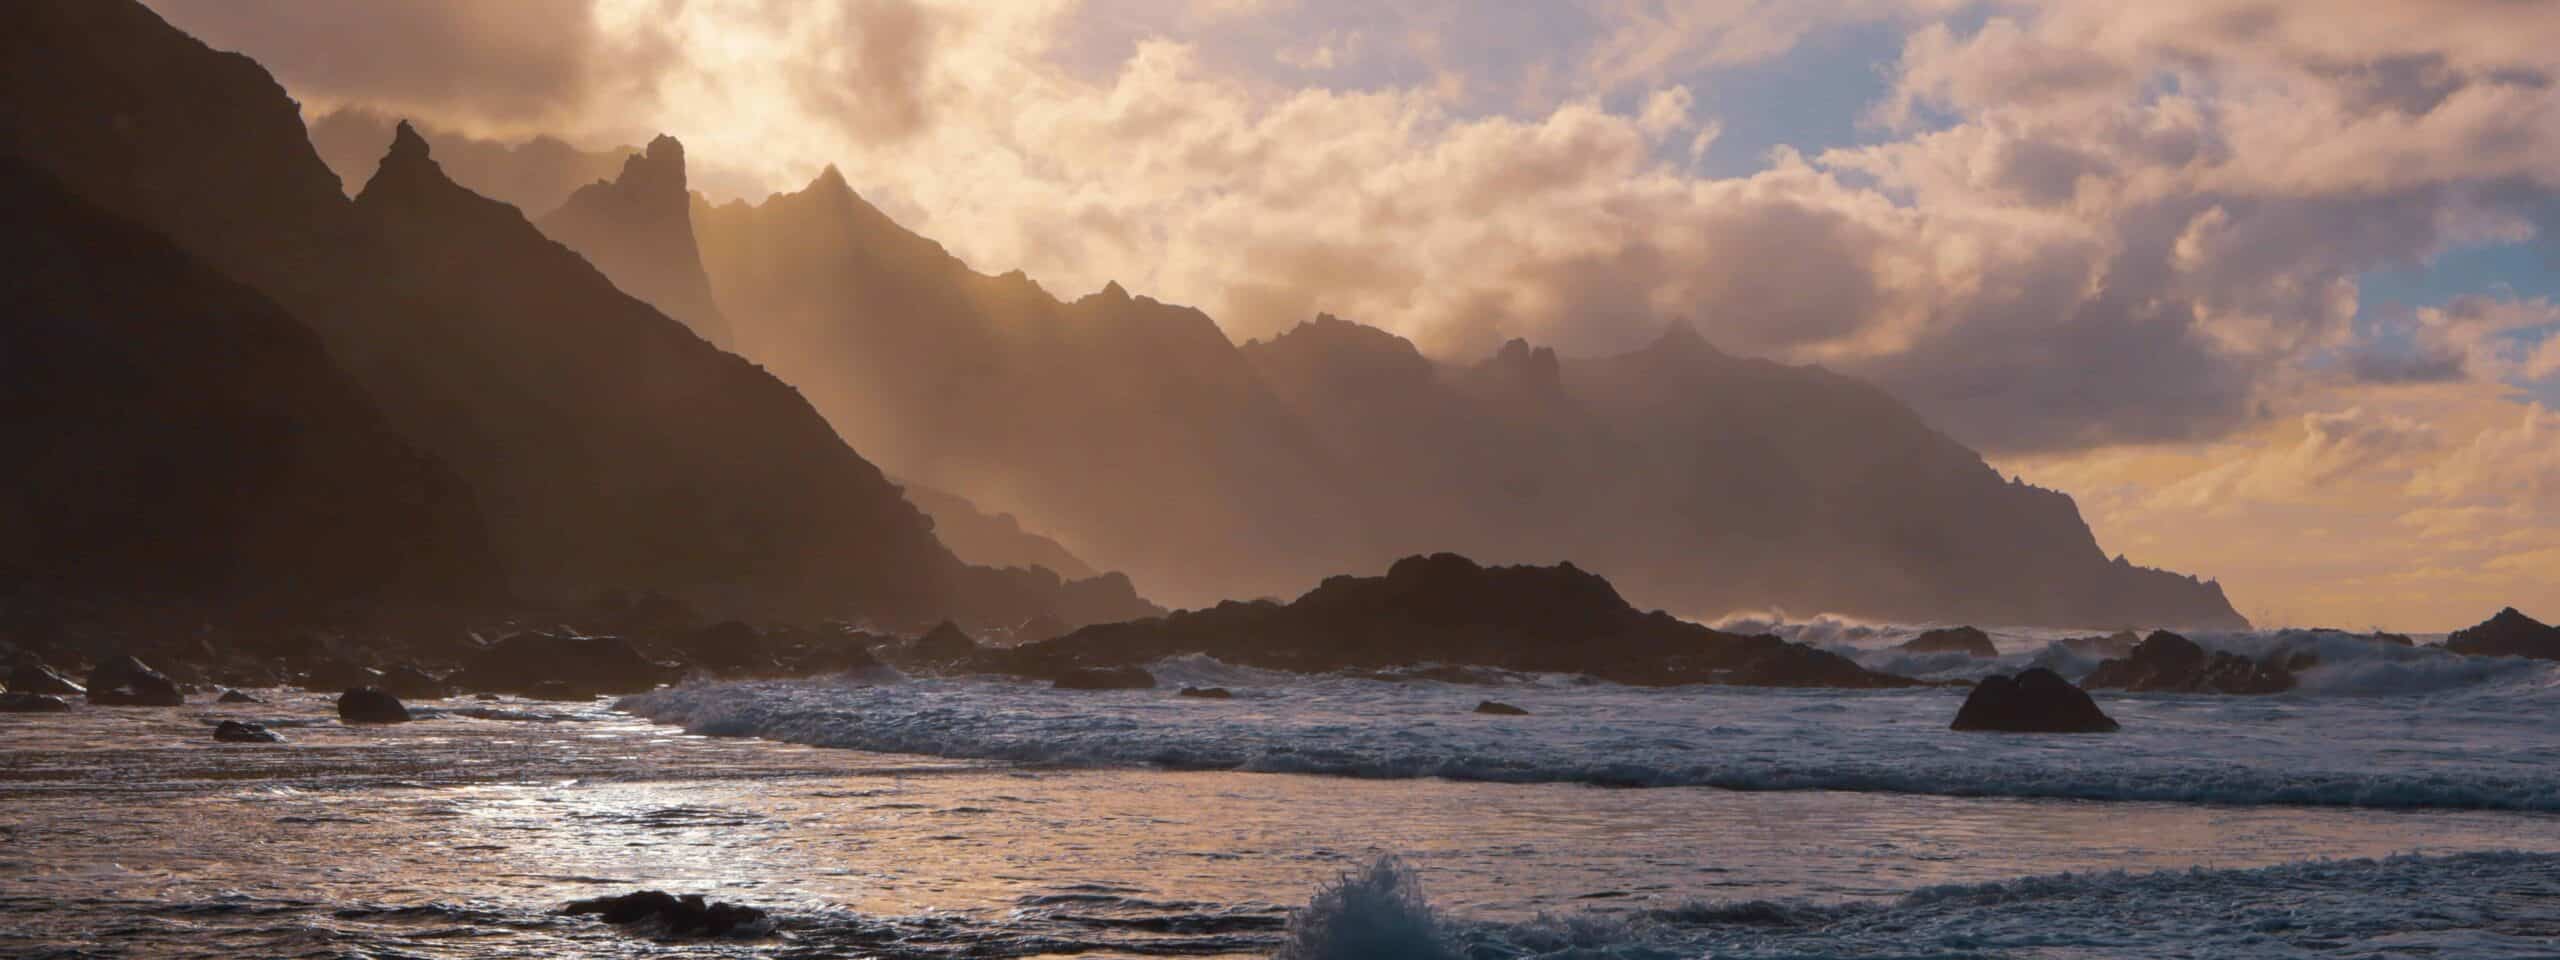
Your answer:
0,156 -> 502,620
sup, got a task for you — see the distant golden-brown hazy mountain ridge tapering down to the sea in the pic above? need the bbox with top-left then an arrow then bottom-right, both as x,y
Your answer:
694,169 -> 2243,627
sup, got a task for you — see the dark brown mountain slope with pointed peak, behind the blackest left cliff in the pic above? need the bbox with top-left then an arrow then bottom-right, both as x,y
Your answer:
0,0 -> 1149,632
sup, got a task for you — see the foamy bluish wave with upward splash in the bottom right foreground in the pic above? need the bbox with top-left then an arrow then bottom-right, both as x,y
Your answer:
1280,852 -> 2560,960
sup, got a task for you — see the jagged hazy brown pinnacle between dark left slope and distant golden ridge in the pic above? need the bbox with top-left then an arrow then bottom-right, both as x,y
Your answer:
535,136 -> 730,348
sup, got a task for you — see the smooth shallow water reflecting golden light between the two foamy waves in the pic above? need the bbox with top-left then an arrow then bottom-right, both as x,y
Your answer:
15,699 -> 2560,957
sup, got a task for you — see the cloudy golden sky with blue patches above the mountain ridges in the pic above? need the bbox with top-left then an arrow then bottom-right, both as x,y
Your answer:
151,0 -> 2560,630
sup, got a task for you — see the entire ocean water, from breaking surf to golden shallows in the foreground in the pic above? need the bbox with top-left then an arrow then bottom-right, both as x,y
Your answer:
0,622 -> 2560,957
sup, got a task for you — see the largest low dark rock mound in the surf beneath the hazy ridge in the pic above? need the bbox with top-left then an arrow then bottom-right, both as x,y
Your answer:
983,553 -> 1917,686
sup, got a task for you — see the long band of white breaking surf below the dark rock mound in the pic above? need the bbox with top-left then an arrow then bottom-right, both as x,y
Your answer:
622,637 -> 2560,812
